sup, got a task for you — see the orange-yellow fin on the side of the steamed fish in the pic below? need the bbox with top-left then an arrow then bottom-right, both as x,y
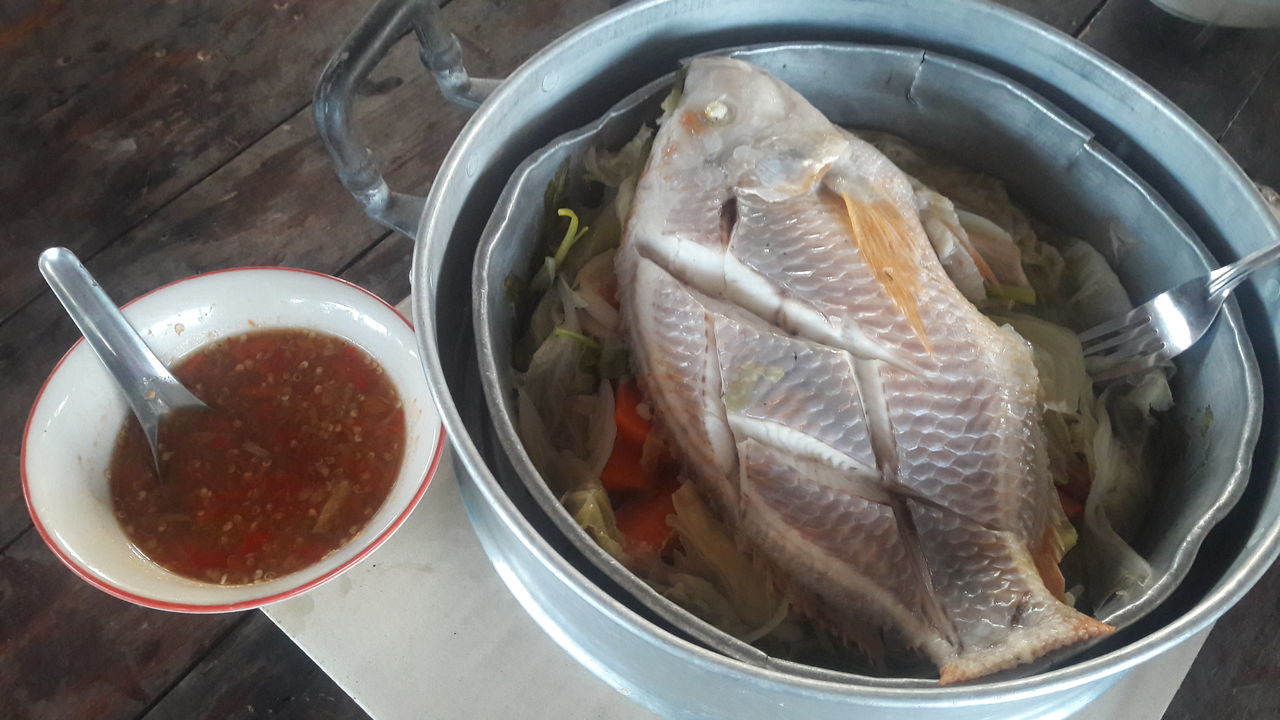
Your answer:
840,192 -> 933,352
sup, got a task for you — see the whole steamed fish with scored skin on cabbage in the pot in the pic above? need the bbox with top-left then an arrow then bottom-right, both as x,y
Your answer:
616,58 -> 1112,683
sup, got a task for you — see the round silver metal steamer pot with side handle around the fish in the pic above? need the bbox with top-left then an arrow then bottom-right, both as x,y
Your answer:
316,0 -> 1280,719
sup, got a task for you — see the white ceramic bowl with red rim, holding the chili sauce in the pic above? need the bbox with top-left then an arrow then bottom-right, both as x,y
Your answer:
20,268 -> 444,612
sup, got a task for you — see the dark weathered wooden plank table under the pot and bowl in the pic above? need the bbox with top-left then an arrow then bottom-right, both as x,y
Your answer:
0,0 -> 1280,720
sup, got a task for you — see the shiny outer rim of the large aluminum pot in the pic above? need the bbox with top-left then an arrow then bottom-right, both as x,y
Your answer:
412,0 -> 1280,707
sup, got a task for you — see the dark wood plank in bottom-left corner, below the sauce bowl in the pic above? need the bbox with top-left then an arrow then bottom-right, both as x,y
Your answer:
0,532 -> 241,720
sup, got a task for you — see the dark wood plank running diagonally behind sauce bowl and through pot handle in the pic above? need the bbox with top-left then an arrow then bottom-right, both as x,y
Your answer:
0,0 -> 614,547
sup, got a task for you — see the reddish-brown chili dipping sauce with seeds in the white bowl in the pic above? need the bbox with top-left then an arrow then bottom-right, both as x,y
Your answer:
108,329 -> 404,584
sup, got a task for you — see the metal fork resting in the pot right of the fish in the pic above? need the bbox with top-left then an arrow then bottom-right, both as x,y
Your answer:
1080,239 -> 1280,380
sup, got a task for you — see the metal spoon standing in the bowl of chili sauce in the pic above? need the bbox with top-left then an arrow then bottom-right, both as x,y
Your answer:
38,247 -> 209,473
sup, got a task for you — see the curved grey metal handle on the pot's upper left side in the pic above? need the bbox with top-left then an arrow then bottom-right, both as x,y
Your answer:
314,0 -> 502,237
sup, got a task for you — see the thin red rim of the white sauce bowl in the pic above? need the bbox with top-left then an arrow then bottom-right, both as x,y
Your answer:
18,265 -> 445,614
